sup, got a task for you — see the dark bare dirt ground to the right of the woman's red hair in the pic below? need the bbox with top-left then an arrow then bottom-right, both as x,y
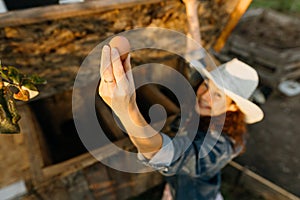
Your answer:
236,93 -> 300,196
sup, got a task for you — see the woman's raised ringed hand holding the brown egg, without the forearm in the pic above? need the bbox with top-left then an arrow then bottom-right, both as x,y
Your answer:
99,45 -> 136,118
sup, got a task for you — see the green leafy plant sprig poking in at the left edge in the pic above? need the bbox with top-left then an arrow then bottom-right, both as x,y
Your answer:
0,61 -> 46,133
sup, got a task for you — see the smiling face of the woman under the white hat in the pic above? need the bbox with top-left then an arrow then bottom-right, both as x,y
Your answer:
195,79 -> 237,117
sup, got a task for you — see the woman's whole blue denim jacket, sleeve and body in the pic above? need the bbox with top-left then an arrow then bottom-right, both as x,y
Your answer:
138,131 -> 241,200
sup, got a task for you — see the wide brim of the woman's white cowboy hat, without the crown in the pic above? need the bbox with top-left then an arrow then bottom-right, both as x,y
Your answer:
194,60 -> 264,124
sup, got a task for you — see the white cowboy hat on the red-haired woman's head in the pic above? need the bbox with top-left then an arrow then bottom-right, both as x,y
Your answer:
191,59 -> 264,124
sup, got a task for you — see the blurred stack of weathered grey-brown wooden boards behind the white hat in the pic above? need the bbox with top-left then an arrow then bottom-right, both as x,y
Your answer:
220,9 -> 300,88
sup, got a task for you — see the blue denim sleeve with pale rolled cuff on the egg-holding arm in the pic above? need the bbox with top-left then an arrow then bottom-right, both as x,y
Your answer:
138,132 -> 240,179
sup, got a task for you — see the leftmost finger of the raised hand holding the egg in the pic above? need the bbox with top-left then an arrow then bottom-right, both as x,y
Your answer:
100,45 -> 115,82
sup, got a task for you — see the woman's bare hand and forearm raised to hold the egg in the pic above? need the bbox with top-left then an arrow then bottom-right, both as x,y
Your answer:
99,45 -> 162,158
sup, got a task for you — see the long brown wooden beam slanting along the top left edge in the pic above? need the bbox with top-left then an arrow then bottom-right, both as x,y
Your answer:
0,0 -> 165,27
